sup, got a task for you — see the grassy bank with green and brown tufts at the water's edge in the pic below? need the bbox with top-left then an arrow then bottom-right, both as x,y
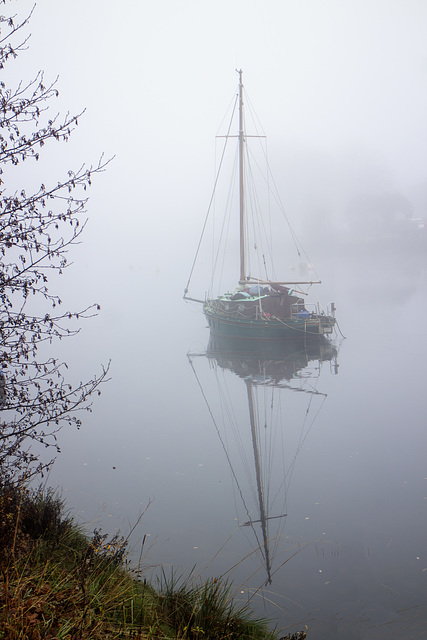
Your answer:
0,486 -> 305,640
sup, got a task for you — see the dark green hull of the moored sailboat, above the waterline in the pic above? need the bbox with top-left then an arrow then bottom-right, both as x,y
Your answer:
203,305 -> 335,340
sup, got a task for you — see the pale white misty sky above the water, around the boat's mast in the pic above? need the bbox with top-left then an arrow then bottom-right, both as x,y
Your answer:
4,0 -> 427,340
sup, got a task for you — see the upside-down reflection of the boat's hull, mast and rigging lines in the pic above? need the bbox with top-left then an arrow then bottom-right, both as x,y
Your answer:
188,335 -> 338,584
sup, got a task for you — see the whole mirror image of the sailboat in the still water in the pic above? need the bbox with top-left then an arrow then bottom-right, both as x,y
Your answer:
188,335 -> 338,584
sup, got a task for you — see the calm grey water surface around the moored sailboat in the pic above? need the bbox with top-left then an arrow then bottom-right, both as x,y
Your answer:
41,244 -> 427,640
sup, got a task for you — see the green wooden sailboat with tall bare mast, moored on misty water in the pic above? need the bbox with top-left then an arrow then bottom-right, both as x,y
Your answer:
184,70 -> 336,341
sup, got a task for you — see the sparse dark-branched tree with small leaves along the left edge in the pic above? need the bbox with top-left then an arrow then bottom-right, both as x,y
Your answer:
0,0 -> 107,479
